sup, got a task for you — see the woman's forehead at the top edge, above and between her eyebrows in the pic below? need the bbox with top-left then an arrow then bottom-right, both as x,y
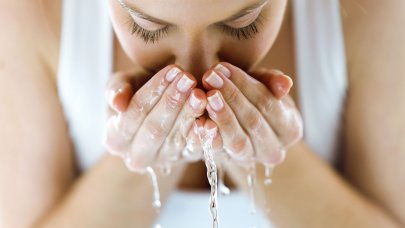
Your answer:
127,0 -> 264,24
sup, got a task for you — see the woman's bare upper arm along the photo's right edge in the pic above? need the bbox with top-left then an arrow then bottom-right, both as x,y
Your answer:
342,0 -> 405,224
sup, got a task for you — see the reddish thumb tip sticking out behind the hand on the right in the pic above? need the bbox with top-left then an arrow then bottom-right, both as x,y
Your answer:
250,68 -> 293,100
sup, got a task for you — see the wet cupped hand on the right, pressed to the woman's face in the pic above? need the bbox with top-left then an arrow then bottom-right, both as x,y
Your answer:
193,63 -> 303,166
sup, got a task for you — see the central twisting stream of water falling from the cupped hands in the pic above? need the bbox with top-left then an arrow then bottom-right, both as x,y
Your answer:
198,127 -> 219,228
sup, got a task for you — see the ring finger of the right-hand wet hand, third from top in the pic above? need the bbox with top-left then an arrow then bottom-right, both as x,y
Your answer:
207,90 -> 254,165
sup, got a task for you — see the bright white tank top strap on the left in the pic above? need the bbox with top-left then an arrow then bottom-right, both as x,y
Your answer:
58,0 -> 112,168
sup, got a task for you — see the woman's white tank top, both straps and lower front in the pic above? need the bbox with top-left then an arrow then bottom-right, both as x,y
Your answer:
58,0 -> 347,225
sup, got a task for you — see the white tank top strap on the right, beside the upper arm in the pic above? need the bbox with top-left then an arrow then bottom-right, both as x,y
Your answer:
293,0 -> 347,162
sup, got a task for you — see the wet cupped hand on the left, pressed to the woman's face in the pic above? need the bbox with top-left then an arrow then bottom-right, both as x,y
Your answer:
104,65 -> 207,172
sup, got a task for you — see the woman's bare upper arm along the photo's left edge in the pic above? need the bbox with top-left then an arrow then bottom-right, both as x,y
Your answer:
0,0 -> 74,227
